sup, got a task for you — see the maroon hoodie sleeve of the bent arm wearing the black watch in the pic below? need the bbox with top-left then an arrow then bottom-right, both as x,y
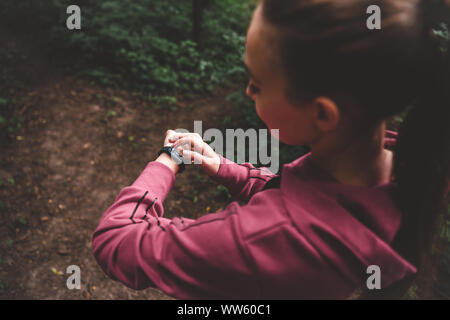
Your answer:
92,162 -> 258,299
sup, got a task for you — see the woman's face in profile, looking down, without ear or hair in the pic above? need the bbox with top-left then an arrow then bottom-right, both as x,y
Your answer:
245,5 -> 315,145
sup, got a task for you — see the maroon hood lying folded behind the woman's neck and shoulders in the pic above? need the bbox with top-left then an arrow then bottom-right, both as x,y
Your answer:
280,153 -> 417,288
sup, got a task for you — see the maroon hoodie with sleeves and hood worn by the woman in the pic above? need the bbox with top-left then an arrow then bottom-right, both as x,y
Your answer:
92,132 -> 417,299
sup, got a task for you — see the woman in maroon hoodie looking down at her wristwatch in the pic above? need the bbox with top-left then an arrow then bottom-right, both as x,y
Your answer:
93,0 -> 450,299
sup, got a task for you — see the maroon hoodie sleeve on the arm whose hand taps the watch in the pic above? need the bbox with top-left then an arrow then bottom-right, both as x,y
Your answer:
211,154 -> 278,202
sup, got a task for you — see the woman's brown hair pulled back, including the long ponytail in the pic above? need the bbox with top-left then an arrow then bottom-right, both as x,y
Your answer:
262,0 -> 450,298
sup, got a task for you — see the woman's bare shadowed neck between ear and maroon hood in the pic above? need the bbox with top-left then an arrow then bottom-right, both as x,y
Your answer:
311,122 -> 392,187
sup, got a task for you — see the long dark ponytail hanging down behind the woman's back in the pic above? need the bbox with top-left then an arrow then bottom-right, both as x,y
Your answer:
393,0 -> 450,298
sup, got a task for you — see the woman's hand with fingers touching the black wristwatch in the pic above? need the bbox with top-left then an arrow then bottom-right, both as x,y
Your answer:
168,132 -> 220,176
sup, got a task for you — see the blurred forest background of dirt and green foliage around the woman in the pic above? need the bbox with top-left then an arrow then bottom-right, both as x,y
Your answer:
0,0 -> 450,299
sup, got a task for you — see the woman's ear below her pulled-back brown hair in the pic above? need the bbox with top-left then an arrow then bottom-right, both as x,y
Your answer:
313,97 -> 341,132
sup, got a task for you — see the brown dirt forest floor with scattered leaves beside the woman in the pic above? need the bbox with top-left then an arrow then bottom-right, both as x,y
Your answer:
0,28 -> 243,299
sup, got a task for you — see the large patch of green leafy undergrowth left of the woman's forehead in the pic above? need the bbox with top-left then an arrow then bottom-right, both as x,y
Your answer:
0,0 -> 254,96
